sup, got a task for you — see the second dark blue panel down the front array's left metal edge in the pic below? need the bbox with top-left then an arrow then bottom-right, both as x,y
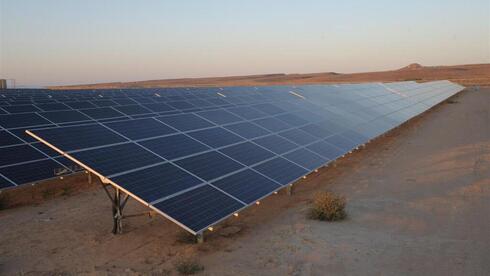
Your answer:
71,143 -> 164,176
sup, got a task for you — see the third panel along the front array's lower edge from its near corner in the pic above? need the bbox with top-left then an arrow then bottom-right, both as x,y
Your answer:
254,157 -> 308,185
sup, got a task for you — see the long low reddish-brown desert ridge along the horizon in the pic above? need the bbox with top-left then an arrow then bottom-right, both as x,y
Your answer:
49,63 -> 490,89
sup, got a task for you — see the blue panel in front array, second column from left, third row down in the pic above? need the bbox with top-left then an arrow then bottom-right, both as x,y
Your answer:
176,151 -> 243,181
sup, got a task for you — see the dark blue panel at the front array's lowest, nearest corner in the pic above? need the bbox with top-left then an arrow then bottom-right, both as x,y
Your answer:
154,185 -> 245,232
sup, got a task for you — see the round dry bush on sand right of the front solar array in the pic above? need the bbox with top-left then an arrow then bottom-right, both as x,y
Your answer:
308,192 -> 347,221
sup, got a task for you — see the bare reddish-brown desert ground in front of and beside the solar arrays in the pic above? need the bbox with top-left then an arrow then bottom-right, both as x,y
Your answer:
0,89 -> 490,276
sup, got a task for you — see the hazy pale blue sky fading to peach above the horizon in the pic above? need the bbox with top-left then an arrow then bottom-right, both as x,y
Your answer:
0,0 -> 490,86
